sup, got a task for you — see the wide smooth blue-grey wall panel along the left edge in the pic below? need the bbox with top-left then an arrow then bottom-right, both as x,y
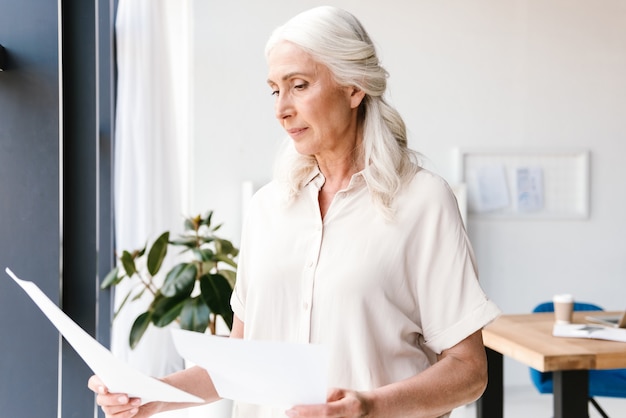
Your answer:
0,0 -> 60,418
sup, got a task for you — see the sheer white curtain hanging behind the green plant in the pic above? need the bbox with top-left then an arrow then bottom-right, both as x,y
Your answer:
111,0 -> 189,376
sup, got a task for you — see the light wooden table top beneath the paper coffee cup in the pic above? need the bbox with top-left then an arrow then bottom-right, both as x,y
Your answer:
483,311 -> 626,372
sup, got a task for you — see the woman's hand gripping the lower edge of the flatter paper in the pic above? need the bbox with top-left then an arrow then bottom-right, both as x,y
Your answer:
285,389 -> 372,418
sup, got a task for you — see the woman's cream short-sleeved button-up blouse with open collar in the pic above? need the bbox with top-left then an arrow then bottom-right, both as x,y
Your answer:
231,169 -> 500,418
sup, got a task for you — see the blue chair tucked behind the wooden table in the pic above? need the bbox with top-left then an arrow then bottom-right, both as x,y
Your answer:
530,302 -> 626,418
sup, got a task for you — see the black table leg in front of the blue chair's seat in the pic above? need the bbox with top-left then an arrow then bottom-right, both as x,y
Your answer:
553,370 -> 589,418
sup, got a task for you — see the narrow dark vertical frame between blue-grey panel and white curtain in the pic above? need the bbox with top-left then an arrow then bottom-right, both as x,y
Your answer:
60,0 -> 114,418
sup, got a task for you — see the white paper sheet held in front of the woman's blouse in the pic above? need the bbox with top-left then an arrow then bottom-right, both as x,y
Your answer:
172,329 -> 328,408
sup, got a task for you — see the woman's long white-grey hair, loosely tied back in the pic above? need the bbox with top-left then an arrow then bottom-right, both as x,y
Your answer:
265,6 -> 418,218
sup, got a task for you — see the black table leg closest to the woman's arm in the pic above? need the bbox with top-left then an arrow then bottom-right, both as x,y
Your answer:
476,347 -> 504,418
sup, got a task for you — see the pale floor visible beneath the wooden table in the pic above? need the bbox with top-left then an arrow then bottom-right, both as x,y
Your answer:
452,386 -> 626,418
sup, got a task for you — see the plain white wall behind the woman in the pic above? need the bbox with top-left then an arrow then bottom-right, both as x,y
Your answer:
190,0 -> 626,384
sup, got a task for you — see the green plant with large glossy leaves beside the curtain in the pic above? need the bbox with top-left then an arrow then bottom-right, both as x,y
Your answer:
101,212 -> 239,348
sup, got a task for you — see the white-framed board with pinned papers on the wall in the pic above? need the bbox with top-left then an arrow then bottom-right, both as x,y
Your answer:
455,148 -> 590,219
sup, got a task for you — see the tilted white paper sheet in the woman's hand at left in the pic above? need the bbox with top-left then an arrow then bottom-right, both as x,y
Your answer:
5,268 -> 204,403
